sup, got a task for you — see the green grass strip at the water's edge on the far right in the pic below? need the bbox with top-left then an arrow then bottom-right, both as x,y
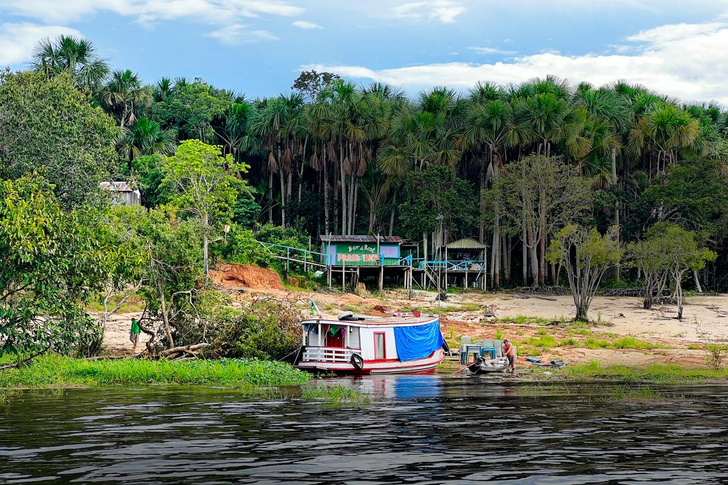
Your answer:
561,361 -> 728,384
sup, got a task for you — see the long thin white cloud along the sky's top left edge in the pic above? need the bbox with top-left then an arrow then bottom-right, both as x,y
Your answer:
0,0 -> 305,24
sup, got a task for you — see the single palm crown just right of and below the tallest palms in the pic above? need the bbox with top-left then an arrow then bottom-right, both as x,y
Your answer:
100,69 -> 152,128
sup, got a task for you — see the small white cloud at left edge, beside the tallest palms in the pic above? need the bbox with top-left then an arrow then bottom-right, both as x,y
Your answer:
0,22 -> 83,66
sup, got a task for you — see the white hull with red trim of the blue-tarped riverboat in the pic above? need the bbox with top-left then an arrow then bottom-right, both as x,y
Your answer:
296,349 -> 445,375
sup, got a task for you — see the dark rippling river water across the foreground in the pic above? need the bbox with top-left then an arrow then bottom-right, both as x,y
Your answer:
0,376 -> 728,485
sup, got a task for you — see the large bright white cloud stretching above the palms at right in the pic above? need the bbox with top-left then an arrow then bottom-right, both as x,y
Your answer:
303,22 -> 728,106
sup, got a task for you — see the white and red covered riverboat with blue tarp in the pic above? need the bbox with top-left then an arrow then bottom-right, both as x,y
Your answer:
295,312 -> 445,374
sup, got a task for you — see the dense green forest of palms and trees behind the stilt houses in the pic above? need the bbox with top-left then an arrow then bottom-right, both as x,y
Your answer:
0,37 -> 728,356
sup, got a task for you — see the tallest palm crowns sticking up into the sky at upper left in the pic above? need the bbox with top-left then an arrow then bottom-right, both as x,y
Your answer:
31,35 -> 109,91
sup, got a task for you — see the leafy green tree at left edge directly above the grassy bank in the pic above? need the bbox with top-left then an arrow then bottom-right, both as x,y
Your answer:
0,175 -> 143,353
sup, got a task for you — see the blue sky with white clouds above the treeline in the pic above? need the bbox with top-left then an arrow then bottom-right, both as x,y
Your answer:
0,0 -> 728,104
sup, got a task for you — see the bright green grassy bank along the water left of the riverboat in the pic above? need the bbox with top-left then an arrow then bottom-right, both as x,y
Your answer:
0,355 -> 310,390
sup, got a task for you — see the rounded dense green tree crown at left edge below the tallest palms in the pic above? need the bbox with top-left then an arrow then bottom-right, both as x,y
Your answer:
0,72 -> 117,209
